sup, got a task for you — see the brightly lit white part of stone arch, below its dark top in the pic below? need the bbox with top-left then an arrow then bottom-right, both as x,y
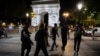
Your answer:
32,4 -> 60,27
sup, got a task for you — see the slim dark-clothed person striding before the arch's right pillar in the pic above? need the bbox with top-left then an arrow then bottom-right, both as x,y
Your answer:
50,24 -> 59,51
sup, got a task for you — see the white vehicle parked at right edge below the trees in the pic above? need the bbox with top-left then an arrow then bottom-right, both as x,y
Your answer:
84,27 -> 100,36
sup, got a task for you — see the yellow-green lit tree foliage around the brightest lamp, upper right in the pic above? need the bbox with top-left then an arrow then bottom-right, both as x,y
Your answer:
72,0 -> 100,26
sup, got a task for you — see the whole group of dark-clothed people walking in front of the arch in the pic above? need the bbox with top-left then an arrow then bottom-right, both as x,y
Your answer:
21,22 -> 83,56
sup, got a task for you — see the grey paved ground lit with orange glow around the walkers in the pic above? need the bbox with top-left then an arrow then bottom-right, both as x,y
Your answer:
0,33 -> 100,56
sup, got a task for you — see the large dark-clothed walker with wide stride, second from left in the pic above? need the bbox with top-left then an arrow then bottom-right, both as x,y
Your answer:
34,24 -> 48,56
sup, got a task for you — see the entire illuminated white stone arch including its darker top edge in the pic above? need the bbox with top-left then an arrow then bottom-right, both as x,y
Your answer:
31,0 -> 60,26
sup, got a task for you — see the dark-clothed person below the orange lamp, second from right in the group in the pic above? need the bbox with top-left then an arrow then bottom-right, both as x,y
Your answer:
61,24 -> 69,51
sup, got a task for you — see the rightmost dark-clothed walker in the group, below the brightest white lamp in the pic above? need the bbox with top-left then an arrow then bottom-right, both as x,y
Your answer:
74,22 -> 84,55
